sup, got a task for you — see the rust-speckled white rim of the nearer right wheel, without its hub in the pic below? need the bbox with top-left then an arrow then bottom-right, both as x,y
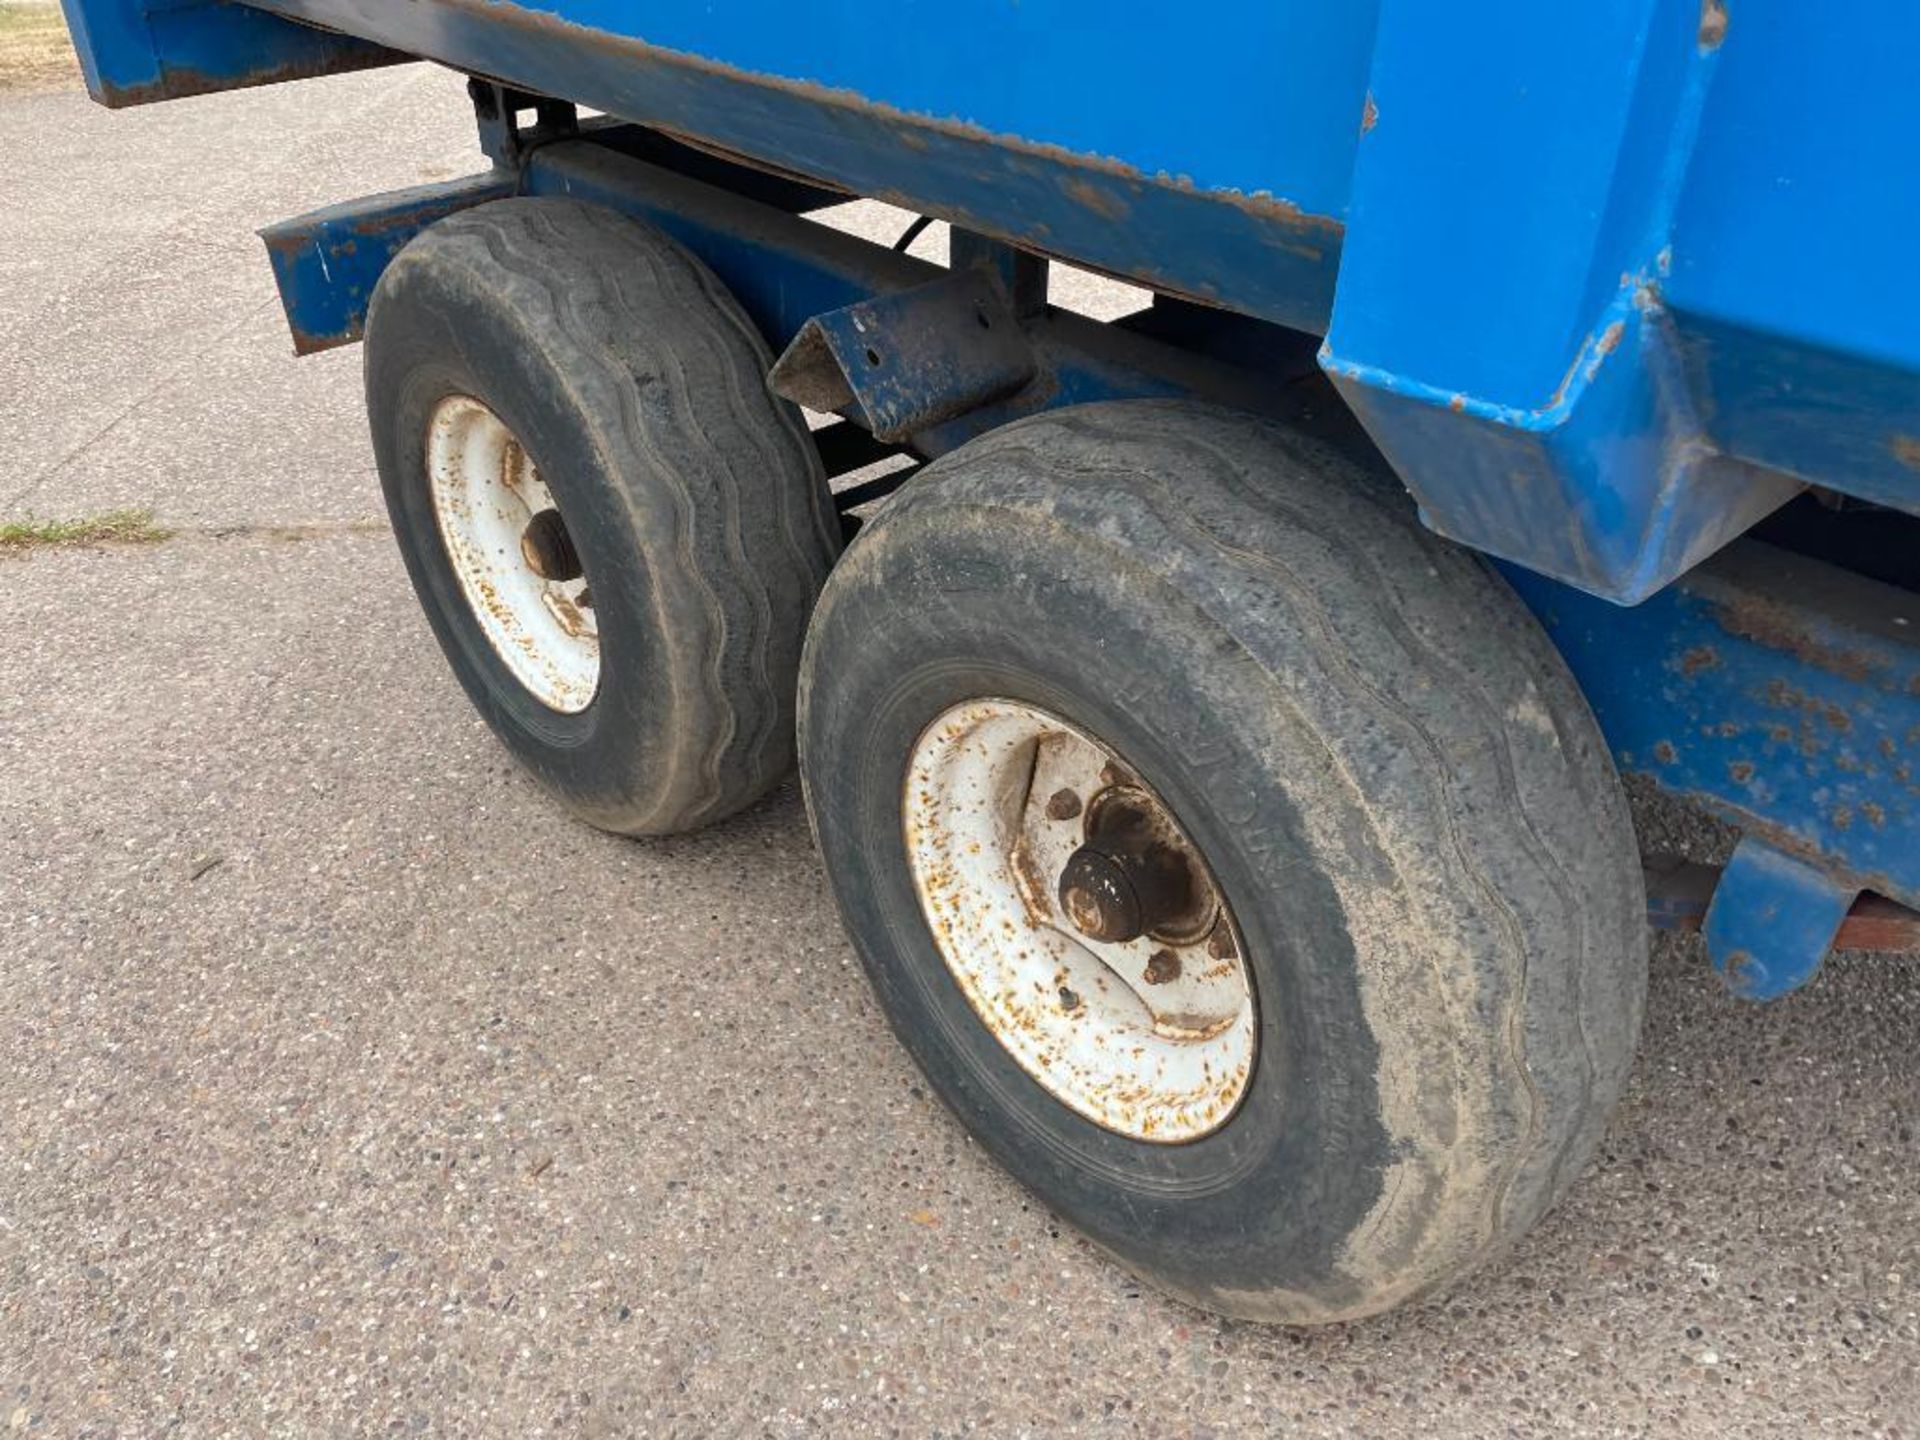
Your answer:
902,699 -> 1258,1144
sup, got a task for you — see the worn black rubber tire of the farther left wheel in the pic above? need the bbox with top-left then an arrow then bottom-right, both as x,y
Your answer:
365,200 -> 839,835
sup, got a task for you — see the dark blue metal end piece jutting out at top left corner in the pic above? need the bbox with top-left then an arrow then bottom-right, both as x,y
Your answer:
61,0 -> 405,108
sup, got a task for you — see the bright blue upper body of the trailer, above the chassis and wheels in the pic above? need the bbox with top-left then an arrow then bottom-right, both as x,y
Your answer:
69,0 -> 1920,601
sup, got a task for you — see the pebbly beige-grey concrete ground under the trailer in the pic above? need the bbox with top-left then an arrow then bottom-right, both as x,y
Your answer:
0,59 -> 1920,1436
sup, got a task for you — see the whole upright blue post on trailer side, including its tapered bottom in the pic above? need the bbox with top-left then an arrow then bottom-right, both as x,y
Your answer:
1323,0 -> 1799,603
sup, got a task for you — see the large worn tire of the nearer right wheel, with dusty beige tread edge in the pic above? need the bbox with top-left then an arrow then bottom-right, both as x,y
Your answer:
801,401 -> 1645,1323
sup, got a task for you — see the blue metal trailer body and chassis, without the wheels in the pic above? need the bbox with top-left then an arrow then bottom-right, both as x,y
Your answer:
56,0 -> 1920,995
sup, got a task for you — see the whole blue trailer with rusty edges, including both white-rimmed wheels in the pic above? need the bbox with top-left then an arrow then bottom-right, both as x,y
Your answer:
67,0 -> 1920,1323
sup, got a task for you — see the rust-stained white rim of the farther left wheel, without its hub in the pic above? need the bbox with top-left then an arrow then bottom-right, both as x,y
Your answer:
426,396 -> 601,714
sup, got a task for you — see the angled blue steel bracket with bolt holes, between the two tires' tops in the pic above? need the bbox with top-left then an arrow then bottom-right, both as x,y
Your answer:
768,269 -> 1039,444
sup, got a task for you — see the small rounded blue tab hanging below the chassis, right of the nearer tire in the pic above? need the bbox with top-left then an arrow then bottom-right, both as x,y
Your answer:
1701,835 -> 1859,1000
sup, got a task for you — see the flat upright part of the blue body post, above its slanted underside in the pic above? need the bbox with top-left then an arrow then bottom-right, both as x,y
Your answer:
1329,0 -> 1709,415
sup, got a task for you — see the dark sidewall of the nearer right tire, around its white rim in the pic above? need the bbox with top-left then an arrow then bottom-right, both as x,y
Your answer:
803,509 -> 1388,1306
